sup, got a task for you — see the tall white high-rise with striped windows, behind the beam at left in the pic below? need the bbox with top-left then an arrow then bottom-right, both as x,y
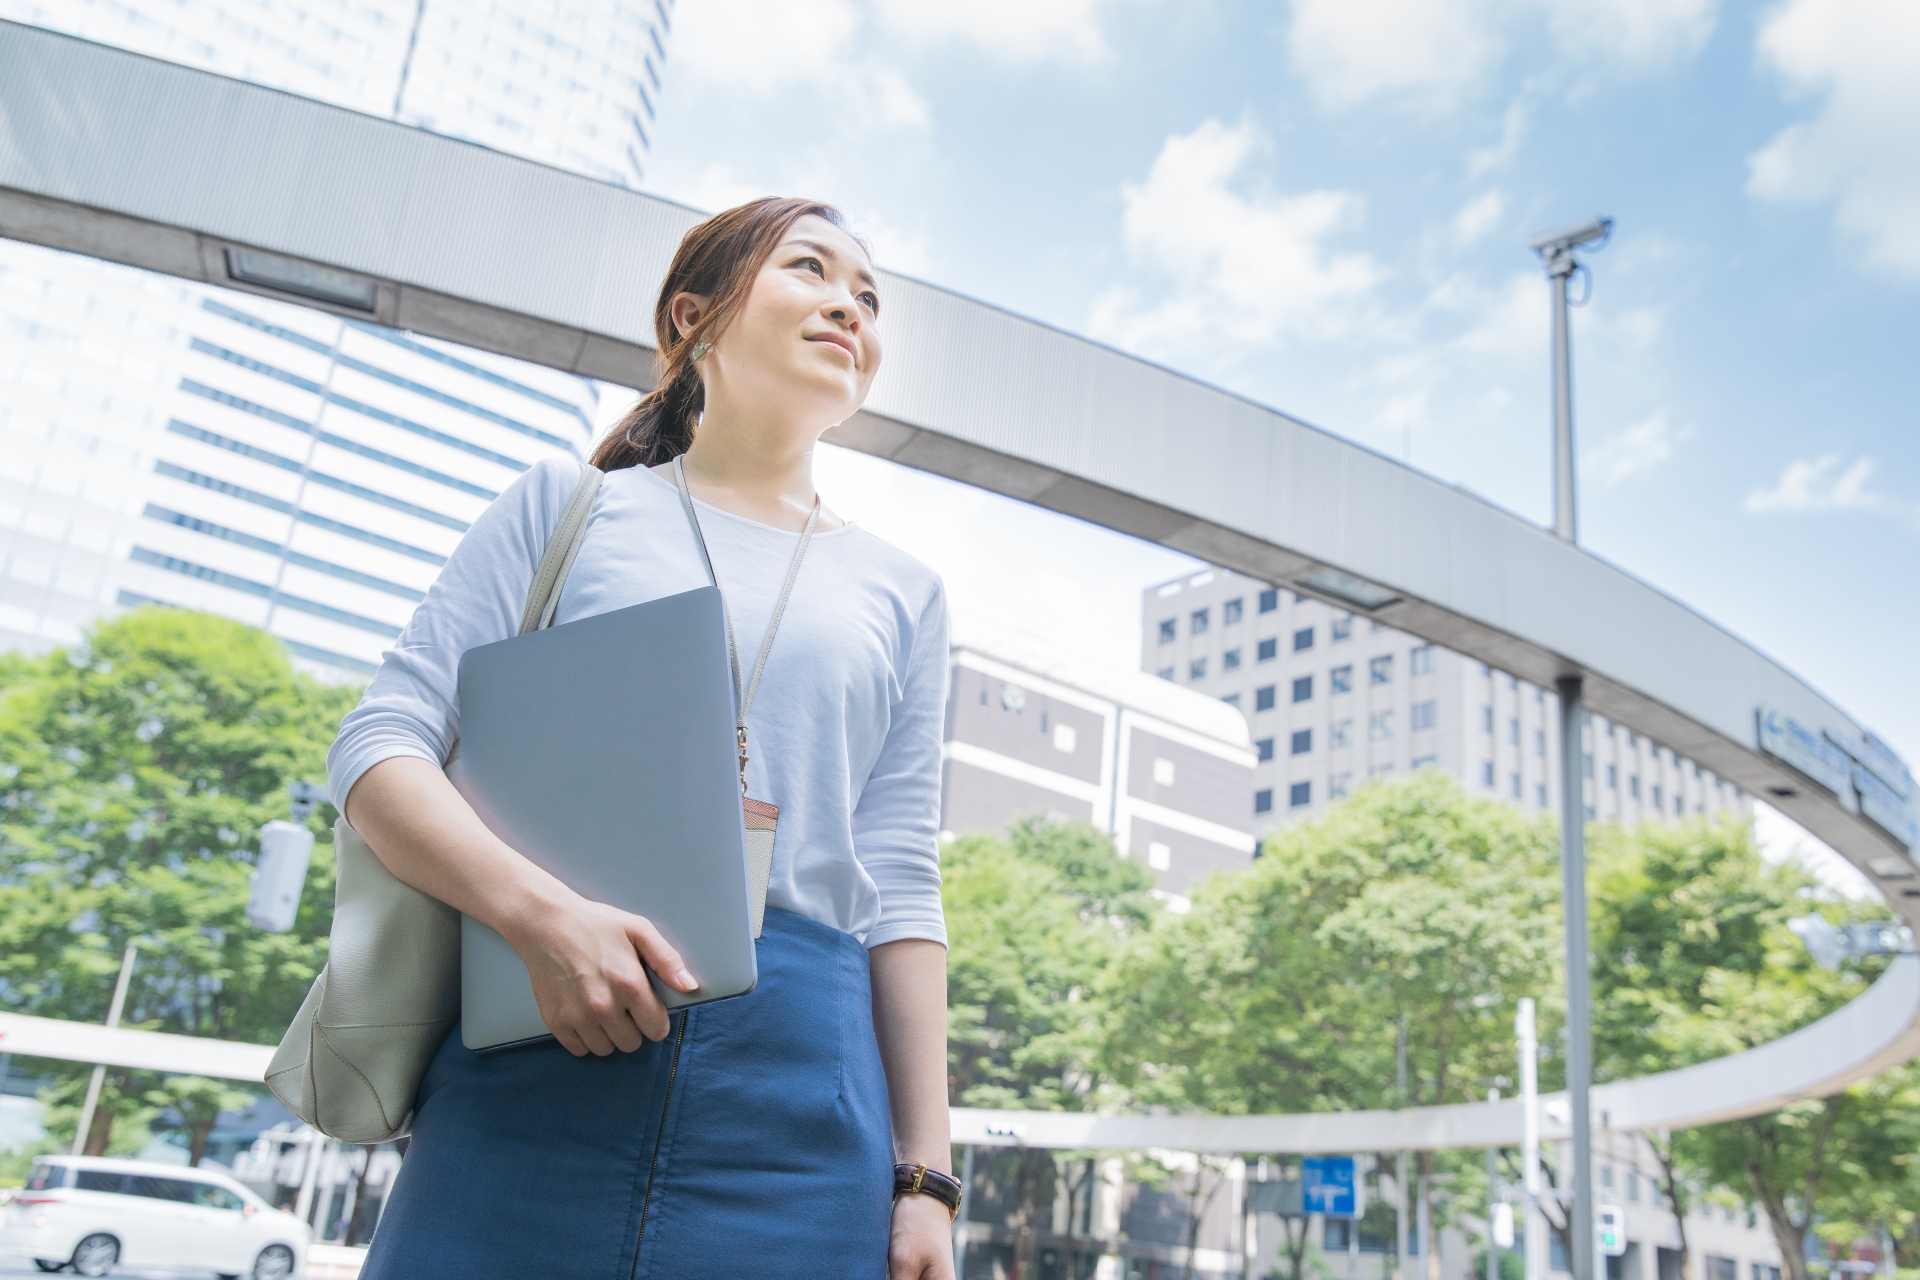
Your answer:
0,0 -> 672,677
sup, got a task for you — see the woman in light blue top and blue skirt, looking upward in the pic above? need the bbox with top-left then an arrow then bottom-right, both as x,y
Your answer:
328,200 -> 952,1280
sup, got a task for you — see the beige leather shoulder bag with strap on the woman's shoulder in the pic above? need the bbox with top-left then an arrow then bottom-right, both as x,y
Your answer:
267,466 -> 602,1144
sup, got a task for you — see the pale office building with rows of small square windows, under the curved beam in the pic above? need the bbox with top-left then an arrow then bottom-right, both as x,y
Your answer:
1140,568 -> 1751,829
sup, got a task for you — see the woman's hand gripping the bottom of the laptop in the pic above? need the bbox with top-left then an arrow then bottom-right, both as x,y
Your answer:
503,892 -> 699,1057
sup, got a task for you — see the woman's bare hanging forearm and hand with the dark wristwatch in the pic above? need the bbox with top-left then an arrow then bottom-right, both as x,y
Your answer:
868,938 -> 954,1280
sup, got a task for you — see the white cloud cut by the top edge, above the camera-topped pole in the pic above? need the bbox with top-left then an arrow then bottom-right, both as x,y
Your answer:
1288,0 -> 1718,111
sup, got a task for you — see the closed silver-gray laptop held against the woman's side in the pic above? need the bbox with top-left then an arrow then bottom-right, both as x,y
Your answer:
457,587 -> 756,1050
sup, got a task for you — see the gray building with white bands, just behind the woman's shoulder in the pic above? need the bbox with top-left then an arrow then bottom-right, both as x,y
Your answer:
941,629 -> 1254,902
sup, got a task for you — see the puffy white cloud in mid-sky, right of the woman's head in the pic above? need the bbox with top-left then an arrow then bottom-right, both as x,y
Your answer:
1092,121 -> 1382,353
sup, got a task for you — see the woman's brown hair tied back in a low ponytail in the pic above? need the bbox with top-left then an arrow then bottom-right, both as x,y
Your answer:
593,196 -> 847,470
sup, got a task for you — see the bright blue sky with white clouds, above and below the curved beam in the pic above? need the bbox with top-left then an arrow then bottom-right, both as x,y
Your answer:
633,0 -> 1920,782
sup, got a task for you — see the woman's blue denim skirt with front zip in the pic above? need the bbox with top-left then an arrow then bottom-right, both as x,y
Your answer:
361,908 -> 893,1280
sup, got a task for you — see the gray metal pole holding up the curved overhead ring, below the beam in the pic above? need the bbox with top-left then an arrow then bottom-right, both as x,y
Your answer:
1557,676 -> 1596,1280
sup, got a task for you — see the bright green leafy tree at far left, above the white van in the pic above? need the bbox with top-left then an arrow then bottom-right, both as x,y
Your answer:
0,606 -> 357,1146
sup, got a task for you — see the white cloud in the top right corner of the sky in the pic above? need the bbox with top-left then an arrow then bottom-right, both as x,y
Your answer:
1747,0 -> 1920,278
